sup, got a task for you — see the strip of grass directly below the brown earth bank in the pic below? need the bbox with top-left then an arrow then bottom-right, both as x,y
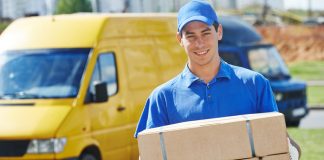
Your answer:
288,61 -> 324,81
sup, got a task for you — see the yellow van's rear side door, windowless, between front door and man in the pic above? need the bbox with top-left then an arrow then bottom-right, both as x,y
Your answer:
121,37 -> 163,159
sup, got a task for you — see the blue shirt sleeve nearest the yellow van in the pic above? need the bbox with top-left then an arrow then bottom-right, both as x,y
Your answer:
134,91 -> 169,138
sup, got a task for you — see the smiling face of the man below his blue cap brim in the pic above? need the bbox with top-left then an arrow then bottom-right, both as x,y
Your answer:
177,21 -> 222,67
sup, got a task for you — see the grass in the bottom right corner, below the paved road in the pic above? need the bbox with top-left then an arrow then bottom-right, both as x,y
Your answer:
288,128 -> 324,160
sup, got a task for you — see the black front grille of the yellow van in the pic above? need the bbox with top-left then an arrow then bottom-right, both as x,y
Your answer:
0,140 -> 29,157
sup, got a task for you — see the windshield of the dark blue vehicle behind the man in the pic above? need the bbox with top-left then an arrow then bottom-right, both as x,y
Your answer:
248,47 -> 289,79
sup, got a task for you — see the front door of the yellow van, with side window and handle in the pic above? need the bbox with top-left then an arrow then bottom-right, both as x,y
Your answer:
86,52 -> 132,160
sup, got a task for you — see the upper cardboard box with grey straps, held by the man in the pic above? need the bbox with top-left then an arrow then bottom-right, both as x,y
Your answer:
138,112 -> 288,160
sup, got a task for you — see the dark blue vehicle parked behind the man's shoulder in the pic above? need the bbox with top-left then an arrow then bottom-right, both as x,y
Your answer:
219,16 -> 308,126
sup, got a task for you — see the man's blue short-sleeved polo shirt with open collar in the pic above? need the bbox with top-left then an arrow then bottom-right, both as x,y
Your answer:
135,60 -> 278,137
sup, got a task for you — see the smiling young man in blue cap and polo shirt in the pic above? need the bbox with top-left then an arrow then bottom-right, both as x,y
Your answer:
135,0 -> 302,159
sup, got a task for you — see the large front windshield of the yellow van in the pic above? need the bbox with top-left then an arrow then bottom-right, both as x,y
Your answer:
0,49 -> 90,99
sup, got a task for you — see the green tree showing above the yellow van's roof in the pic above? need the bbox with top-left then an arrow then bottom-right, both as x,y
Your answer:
55,0 -> 92,14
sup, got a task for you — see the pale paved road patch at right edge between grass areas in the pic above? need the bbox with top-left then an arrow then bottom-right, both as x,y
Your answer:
299,108 -> 324,129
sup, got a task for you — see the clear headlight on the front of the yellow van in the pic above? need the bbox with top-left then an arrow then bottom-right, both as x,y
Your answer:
27,138 -> 66,154
